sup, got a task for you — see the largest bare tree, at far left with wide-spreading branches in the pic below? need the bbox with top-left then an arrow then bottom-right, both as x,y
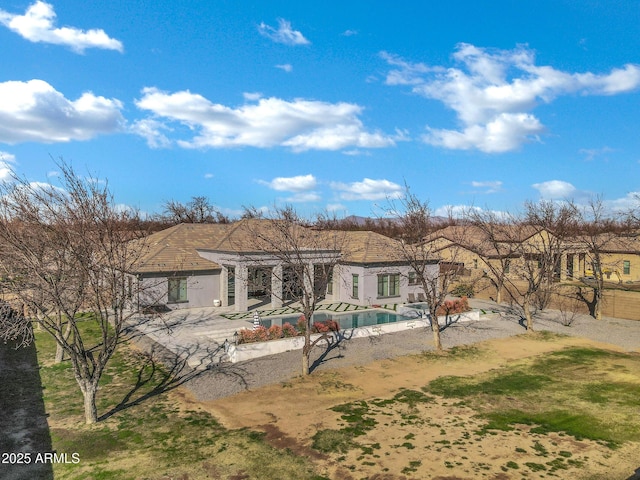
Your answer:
0,163 -> 151,424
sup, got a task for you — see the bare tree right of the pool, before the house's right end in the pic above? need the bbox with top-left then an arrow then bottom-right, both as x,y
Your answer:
388,187 -> 464,351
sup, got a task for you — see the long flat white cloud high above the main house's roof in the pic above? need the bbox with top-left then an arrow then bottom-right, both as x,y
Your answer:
136,88 -> 397,151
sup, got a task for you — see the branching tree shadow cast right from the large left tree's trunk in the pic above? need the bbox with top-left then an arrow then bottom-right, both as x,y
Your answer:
99,337 -> 248,421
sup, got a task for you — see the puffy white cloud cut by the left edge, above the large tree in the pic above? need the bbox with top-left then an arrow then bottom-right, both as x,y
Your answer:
0,80 -> 125,144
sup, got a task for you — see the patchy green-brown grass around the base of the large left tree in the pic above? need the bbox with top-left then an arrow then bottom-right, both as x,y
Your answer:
36,320 -> 321,480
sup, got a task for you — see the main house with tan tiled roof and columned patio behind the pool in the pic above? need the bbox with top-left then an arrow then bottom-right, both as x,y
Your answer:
136,219 -> 438,311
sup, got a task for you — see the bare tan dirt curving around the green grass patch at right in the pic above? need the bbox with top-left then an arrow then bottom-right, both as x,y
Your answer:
180,336 -> 640,480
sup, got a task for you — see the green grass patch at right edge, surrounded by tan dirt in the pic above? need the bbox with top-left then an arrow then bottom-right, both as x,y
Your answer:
423,348 -> 640,448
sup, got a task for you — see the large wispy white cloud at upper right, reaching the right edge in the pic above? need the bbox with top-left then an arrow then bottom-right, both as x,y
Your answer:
380,43 -> 640,153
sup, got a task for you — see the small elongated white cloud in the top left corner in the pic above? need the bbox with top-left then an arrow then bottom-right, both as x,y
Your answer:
0,1 -> 123,53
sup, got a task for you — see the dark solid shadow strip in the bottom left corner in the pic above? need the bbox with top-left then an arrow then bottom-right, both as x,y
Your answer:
0,342 -> 53,480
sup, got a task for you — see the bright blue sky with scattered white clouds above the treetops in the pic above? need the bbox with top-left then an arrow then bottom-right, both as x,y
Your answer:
0,0 -> 640,216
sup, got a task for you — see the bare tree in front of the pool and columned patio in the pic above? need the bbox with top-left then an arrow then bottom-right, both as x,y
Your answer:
239,206 -> 345,375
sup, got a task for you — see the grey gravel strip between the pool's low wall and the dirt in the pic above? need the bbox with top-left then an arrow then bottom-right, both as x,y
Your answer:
165,301 -> 640,401
